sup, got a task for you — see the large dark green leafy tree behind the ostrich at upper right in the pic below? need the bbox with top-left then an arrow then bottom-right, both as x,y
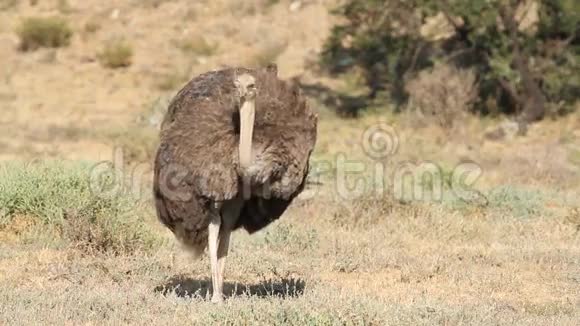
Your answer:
321,0 -> 580,130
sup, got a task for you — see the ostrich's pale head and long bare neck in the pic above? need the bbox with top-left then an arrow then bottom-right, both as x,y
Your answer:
234,74 -> 258,170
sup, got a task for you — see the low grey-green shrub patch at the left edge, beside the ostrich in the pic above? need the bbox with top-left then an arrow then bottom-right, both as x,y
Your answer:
0,161 -> 157,254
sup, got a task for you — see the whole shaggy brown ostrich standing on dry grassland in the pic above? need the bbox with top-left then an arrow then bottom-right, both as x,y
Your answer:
153,65 -> 317,303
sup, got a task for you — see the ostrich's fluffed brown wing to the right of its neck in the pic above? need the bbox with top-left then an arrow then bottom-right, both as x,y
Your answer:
237,68 -> 317,232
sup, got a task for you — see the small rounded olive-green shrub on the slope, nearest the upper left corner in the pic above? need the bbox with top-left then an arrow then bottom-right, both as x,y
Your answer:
17,17 -> 73,51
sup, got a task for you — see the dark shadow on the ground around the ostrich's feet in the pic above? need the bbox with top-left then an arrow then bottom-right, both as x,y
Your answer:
154,275 -> 306,298
